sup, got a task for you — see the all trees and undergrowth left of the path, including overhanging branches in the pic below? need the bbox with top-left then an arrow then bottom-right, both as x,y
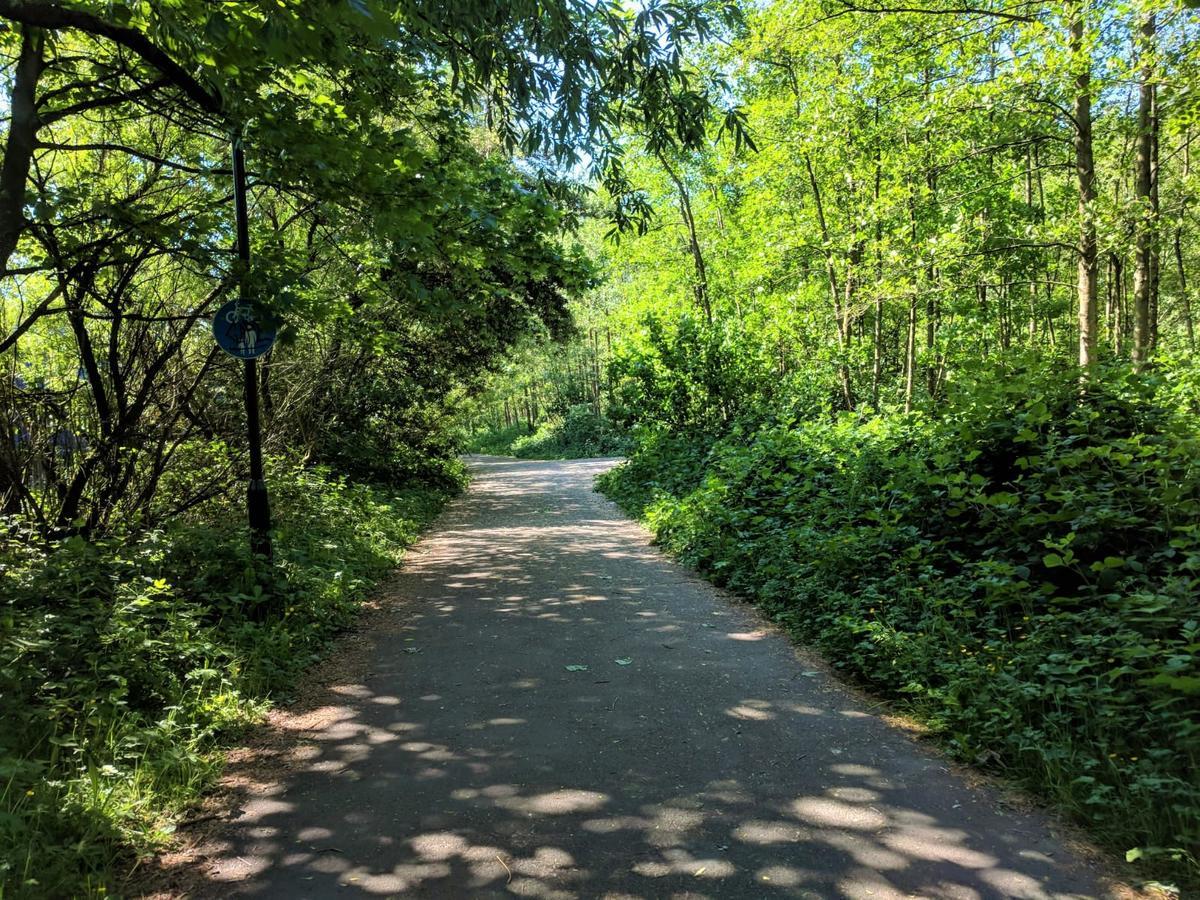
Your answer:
0,0 -> 740,896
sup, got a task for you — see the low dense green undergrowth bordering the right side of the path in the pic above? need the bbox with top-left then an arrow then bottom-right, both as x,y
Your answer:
600,362 -> 1200,877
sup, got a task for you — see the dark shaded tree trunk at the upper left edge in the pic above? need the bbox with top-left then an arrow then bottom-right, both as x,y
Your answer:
0,25 -> 46,275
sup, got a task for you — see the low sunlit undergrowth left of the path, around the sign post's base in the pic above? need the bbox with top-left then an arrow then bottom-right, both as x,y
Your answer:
0,467 -> 458,898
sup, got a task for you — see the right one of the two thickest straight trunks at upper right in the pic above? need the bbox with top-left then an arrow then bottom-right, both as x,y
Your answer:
1133,16 -> 1158,370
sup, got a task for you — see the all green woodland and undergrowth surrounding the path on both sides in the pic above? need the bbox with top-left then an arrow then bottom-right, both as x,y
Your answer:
0,0 -> 1200,896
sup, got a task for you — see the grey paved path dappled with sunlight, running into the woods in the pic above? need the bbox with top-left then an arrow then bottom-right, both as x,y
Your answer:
210,457 -> 1102,900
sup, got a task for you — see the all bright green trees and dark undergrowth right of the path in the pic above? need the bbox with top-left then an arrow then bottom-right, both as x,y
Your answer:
460,0 -> 1200,882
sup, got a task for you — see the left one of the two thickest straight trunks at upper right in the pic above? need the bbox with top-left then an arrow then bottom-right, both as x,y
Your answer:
1070,0 -> 1099,379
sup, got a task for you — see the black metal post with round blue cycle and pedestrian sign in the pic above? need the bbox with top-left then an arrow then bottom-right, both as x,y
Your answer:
212,136 -> 275,559
